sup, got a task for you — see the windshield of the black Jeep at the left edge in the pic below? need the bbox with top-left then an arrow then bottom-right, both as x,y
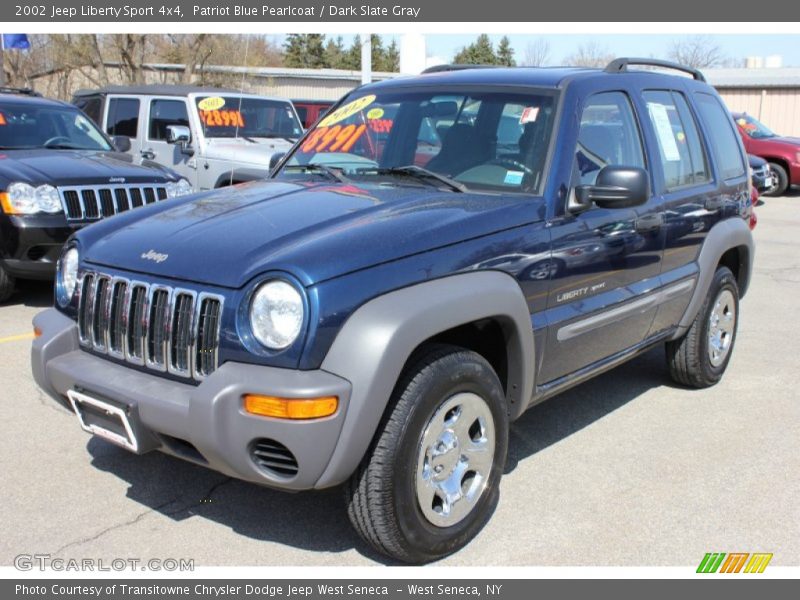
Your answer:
0,103 -> 112,151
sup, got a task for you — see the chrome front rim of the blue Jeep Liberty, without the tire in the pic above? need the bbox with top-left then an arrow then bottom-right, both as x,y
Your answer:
416,392 -> 496,527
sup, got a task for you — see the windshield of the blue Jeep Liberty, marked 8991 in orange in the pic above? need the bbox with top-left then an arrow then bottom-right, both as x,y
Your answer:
276,87 -> 556,193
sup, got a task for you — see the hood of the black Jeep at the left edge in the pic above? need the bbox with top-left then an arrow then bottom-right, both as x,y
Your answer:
0,148 -> 173,185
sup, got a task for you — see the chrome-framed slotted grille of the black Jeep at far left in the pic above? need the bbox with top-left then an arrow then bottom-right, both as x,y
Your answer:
58,184 -> 167,221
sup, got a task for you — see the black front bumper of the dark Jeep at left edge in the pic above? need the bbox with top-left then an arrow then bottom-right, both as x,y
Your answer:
0,215 -> 75,279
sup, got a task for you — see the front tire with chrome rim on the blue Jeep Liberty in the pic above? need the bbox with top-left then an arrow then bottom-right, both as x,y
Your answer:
345,345 -> 508,563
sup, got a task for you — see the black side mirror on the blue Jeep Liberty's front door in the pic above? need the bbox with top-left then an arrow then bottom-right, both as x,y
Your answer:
575,165 -> 650,209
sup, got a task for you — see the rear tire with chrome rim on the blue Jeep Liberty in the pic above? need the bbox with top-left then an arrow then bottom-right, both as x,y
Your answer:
666,267 -> 739,388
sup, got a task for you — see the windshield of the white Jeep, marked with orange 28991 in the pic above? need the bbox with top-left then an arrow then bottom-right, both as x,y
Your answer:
195,96 -> 303,140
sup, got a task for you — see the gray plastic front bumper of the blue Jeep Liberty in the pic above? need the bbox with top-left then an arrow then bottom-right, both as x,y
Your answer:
31,309 -> 351,490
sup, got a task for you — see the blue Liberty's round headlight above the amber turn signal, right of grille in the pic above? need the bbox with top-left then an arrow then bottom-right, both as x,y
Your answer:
250,280 -> 303,350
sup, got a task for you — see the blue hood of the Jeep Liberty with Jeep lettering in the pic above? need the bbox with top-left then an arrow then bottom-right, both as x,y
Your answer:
78,181 -> 544,288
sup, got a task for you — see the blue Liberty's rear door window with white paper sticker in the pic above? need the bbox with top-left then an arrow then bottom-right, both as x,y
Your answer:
643,90 -> 711,190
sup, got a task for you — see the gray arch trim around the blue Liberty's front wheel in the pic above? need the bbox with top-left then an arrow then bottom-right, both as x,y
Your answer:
315,271 -> 535,488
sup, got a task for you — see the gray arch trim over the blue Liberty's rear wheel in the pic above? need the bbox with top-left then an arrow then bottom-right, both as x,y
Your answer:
672,218 -> 755,339
